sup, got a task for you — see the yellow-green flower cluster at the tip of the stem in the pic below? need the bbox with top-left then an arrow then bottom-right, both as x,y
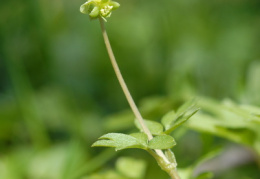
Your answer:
80,0 -> 120,21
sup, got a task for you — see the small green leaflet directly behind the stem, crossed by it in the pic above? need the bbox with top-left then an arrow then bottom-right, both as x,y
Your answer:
135,120 -> 163,135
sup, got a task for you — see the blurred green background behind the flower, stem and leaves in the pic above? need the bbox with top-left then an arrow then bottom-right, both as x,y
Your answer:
0,0 -> 260,179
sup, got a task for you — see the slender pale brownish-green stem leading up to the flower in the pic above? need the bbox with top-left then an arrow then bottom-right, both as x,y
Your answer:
99,18 -> 180,179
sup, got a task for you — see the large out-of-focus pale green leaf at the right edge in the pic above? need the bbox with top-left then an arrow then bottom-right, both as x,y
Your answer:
187,98 -> 259,148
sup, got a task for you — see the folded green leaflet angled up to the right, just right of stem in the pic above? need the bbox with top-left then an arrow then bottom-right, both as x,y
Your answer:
162,100 -> 199,134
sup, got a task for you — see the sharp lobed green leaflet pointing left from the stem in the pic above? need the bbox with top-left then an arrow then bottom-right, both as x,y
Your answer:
92,133 -> 147,150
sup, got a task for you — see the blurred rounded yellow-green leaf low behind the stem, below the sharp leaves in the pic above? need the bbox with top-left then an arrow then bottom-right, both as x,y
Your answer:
116,157 -> 147,178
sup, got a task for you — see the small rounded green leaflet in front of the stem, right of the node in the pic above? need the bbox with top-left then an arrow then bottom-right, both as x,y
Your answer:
148,135 -> 176,149
